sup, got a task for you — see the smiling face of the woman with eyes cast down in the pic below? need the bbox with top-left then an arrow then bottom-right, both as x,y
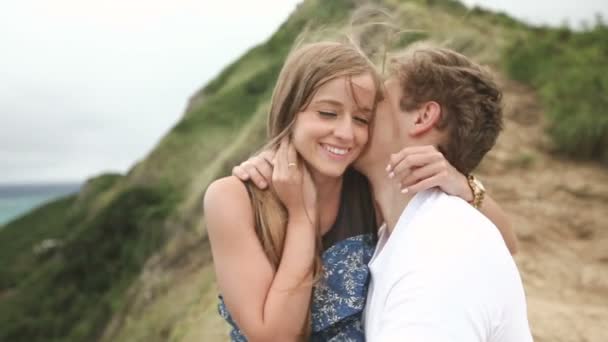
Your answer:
292,74 -> 376,177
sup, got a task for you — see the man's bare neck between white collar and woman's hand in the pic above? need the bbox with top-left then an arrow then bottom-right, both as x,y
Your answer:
365,158 -> 413,232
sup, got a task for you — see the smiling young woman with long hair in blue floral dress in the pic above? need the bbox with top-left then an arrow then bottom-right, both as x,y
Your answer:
205,43 -> 516,341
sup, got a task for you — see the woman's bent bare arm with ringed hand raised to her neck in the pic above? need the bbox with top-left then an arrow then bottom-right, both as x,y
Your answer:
204,138 -> 316,341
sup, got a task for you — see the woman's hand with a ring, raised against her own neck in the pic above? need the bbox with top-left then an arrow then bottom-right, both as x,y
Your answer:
272,138 -> 317,222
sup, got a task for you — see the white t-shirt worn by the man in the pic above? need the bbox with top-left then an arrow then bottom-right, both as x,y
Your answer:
364,189 -> 532,342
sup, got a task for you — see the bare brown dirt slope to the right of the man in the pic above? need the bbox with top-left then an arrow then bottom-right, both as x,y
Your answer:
478,80 -> 608,342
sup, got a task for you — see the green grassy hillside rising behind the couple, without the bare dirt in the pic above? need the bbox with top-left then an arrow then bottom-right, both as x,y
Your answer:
0,0 -> 608,342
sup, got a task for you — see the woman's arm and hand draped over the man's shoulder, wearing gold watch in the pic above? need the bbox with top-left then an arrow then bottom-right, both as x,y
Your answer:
387,145 -> 517,254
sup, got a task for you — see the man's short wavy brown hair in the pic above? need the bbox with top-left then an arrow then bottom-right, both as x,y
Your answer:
391,47 -> 502,174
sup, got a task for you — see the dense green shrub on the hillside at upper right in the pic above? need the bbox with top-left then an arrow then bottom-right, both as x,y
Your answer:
505,19 -> 608,163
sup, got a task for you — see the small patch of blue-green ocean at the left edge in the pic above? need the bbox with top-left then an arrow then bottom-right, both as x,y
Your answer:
0,183 -> 81,229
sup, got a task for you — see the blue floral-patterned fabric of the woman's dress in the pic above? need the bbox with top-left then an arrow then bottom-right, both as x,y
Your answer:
219,234 -> 374,342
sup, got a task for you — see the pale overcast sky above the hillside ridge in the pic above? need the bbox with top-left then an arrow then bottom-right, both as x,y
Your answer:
0,0 -> 608,183
